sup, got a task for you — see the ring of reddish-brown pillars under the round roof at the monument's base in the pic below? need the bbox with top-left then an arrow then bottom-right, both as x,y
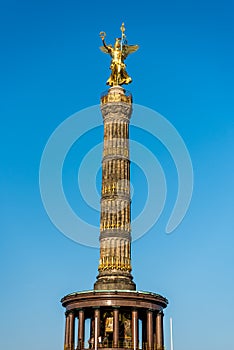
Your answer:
64,307 -> 164,350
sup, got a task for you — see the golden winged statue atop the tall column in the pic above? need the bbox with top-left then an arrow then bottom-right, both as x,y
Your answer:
100,23 -> 139,86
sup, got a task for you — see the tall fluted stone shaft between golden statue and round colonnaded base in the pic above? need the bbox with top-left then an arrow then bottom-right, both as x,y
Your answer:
94,86 -> 136,290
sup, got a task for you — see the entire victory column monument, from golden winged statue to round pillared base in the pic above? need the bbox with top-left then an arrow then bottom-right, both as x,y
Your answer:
61,24 -> 168,350
